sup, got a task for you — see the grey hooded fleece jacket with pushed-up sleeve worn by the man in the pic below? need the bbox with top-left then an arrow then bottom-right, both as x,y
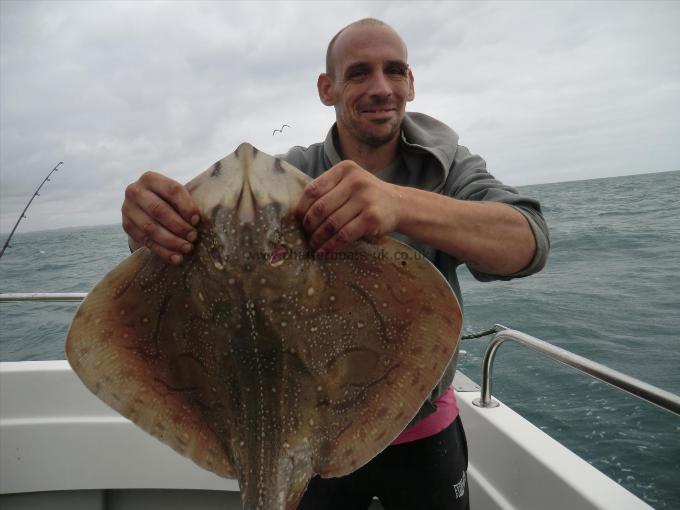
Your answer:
282,112 -> 550,425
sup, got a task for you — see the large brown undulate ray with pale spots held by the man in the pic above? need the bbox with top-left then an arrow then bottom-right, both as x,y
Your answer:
66,144 -> 461,510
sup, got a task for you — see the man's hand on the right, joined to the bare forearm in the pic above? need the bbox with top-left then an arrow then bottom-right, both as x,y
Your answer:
295,161 -> 403,256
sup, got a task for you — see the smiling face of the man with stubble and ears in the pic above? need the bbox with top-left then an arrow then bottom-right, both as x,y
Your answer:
319,25 -> 415,147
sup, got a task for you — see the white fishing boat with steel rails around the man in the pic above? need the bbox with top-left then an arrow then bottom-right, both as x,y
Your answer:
0,294 -> 680,510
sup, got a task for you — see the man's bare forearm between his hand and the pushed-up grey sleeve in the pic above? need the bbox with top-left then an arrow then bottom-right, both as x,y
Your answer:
397,187 -> 536,275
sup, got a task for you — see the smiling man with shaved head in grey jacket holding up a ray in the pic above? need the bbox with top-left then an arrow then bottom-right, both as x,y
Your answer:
123,19 -> 549,510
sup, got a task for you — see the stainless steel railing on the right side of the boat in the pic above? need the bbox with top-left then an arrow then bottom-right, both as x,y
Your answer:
473,324 -> 680,415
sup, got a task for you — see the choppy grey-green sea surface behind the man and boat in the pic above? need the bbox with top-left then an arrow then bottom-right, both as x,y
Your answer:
0,172 -> 680,509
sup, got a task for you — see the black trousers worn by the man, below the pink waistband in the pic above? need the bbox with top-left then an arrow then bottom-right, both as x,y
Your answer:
298,417 -> 470,510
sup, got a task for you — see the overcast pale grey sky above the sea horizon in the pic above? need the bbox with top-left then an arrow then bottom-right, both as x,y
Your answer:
0,0 -> 680,233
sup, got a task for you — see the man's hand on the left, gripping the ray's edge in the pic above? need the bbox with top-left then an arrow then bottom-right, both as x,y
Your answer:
121,172 -> 200,264
